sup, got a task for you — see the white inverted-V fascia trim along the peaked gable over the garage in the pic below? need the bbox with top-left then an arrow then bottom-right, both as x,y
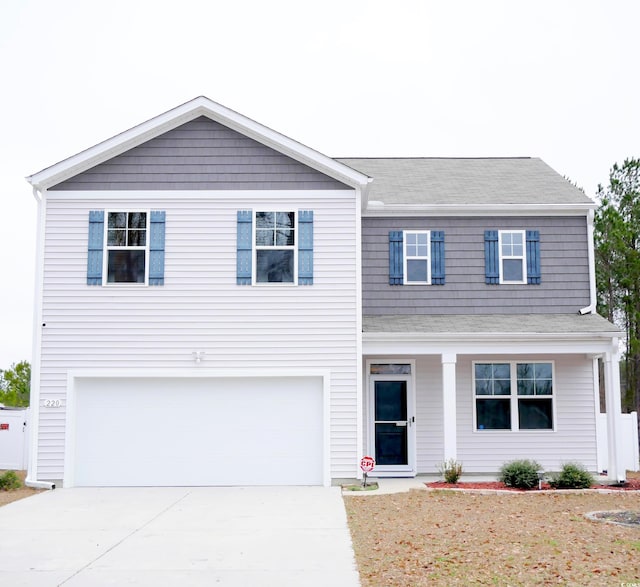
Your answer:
27,96 -> 370,190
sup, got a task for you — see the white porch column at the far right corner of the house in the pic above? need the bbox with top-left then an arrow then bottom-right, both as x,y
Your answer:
603,339 -> 627,481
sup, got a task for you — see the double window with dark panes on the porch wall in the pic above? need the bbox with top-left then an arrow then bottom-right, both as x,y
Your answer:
474,361 -> 553,430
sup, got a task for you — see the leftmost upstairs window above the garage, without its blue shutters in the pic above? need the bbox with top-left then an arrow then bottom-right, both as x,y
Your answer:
106,212 -> 148,283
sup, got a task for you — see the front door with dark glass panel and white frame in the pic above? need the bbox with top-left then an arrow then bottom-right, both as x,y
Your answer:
369,375 -> 415,476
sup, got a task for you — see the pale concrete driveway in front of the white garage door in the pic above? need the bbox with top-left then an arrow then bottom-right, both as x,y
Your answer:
0,487 -> 360,587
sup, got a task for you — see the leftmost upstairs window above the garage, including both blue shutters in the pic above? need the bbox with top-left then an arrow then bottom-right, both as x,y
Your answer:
87,210 -> 166,285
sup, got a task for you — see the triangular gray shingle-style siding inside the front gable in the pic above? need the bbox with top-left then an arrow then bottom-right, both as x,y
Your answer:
50,116 -> 349,190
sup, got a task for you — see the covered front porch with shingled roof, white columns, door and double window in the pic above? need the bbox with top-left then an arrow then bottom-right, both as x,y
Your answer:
362,314 -> 626,481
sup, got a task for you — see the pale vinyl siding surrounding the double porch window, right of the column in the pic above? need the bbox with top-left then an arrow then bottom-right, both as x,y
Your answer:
456,355 -> 597,473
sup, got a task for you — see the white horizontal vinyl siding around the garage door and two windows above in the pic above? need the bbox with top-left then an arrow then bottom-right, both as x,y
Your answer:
38,190 -> 359,479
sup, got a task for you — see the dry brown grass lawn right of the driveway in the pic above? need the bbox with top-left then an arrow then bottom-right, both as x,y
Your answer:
344,482 -> 640,587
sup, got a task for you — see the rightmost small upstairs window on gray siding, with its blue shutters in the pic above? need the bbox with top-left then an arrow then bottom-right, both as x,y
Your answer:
484,230 -> 541,285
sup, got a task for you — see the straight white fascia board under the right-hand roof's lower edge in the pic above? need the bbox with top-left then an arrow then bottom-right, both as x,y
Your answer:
363,202 -> 597,218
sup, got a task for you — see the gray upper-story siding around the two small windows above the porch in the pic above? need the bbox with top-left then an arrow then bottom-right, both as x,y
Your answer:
362,216 -> 589,315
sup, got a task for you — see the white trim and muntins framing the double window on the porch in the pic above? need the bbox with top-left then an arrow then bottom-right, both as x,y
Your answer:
471,358 -> 558,434
